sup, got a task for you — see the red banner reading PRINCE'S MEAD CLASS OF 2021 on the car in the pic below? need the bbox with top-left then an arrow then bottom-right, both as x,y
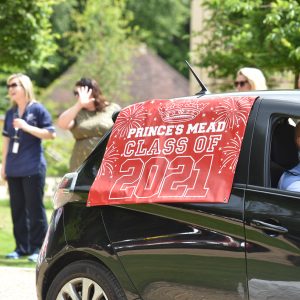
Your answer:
87,96 -> 255,206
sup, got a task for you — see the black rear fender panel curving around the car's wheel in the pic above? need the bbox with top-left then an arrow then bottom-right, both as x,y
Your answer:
37,199 -> 139,300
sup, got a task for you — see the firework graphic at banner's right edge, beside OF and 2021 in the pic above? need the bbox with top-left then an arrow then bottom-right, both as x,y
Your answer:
219,133 -> 242,173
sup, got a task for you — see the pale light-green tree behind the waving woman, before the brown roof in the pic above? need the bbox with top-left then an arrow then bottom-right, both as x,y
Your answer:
41,0 -> 135,113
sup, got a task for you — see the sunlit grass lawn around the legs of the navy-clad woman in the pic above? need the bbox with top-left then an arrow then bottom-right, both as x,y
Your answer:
0,199 -> 53,268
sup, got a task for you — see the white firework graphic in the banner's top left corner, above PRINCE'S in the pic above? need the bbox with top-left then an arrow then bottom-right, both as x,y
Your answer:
112,103 -> 147,137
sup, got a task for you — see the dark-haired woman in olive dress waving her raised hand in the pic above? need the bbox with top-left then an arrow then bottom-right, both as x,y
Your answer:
57,78 -> 120,171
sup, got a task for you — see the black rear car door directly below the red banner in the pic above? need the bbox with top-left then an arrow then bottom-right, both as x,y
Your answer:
102,187 -> 247,300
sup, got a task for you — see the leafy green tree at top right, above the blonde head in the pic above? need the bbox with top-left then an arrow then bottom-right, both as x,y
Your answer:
198,0 -> 300,86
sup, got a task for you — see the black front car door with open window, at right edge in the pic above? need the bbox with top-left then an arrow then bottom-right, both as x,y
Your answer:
245,100 -> 300,300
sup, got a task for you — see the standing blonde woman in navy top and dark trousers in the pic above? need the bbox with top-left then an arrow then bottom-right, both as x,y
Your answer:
1,73 -> 55,262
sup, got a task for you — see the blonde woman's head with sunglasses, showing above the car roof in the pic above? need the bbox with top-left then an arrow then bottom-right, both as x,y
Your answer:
234,68 -> 268,92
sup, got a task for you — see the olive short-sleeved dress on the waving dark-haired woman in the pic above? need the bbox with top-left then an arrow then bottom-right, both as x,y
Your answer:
70,103 -> 121,171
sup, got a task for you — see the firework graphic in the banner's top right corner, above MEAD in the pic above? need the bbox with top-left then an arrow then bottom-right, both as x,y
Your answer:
215,97 -> 252,129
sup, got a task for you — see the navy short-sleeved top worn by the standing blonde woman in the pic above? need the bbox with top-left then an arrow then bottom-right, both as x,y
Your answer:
2,102 -> 55,177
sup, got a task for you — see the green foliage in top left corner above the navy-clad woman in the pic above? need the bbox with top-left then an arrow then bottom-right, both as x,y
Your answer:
0,0 -> 58,72
